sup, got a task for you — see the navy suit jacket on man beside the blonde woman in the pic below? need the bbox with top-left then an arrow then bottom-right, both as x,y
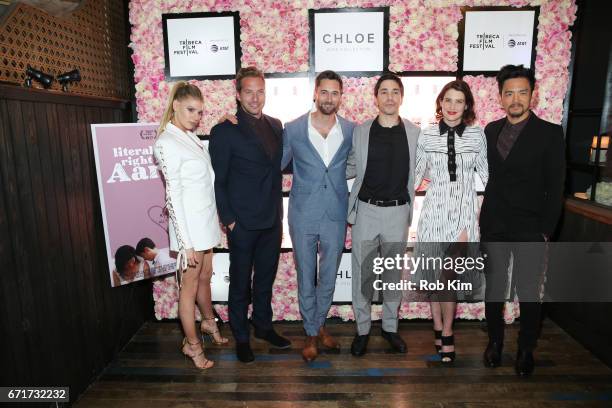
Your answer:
208,109 -> 283,230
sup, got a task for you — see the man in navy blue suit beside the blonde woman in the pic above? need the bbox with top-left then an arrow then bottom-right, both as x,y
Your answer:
209,67 -> 291,363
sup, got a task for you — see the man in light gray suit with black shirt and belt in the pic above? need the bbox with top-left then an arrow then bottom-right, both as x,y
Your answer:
346,73 -> 420,356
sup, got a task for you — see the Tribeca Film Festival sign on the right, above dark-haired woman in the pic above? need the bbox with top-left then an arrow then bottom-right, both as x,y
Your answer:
463,10 -> 536,72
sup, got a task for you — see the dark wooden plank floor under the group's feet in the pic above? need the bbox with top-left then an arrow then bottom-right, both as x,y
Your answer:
76,321 -> 612,408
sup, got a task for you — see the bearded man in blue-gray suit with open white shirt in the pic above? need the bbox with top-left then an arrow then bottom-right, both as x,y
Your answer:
281,71 -> 354,361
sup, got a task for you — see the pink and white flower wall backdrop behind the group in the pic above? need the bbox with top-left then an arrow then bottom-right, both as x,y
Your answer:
130,0 -> 576,321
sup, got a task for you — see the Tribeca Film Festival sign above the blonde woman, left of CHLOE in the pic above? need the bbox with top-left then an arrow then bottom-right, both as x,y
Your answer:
162,12 -> 240,80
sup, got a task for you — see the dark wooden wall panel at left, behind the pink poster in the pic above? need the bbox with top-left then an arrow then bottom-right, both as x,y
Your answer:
0,85 -> 153,400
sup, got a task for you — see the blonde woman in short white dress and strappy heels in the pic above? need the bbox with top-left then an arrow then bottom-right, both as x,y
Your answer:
154,82 -> 228,369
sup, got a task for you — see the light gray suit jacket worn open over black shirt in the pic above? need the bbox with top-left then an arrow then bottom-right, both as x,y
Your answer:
346,119 -> 421,224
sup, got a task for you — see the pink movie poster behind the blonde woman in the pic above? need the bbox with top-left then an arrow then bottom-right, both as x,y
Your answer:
91,123 -> 176,286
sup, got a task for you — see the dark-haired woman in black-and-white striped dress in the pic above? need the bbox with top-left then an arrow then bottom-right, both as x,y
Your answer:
415,80 -> 489,363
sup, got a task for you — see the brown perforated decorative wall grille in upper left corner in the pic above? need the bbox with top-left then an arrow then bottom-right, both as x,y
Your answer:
0,0 -> 130,99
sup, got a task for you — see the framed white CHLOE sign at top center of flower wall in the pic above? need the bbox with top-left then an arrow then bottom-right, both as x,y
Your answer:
309,7 -> 389,76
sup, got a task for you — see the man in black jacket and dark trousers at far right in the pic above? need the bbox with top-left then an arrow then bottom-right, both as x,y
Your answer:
480,65 -> 565,376
